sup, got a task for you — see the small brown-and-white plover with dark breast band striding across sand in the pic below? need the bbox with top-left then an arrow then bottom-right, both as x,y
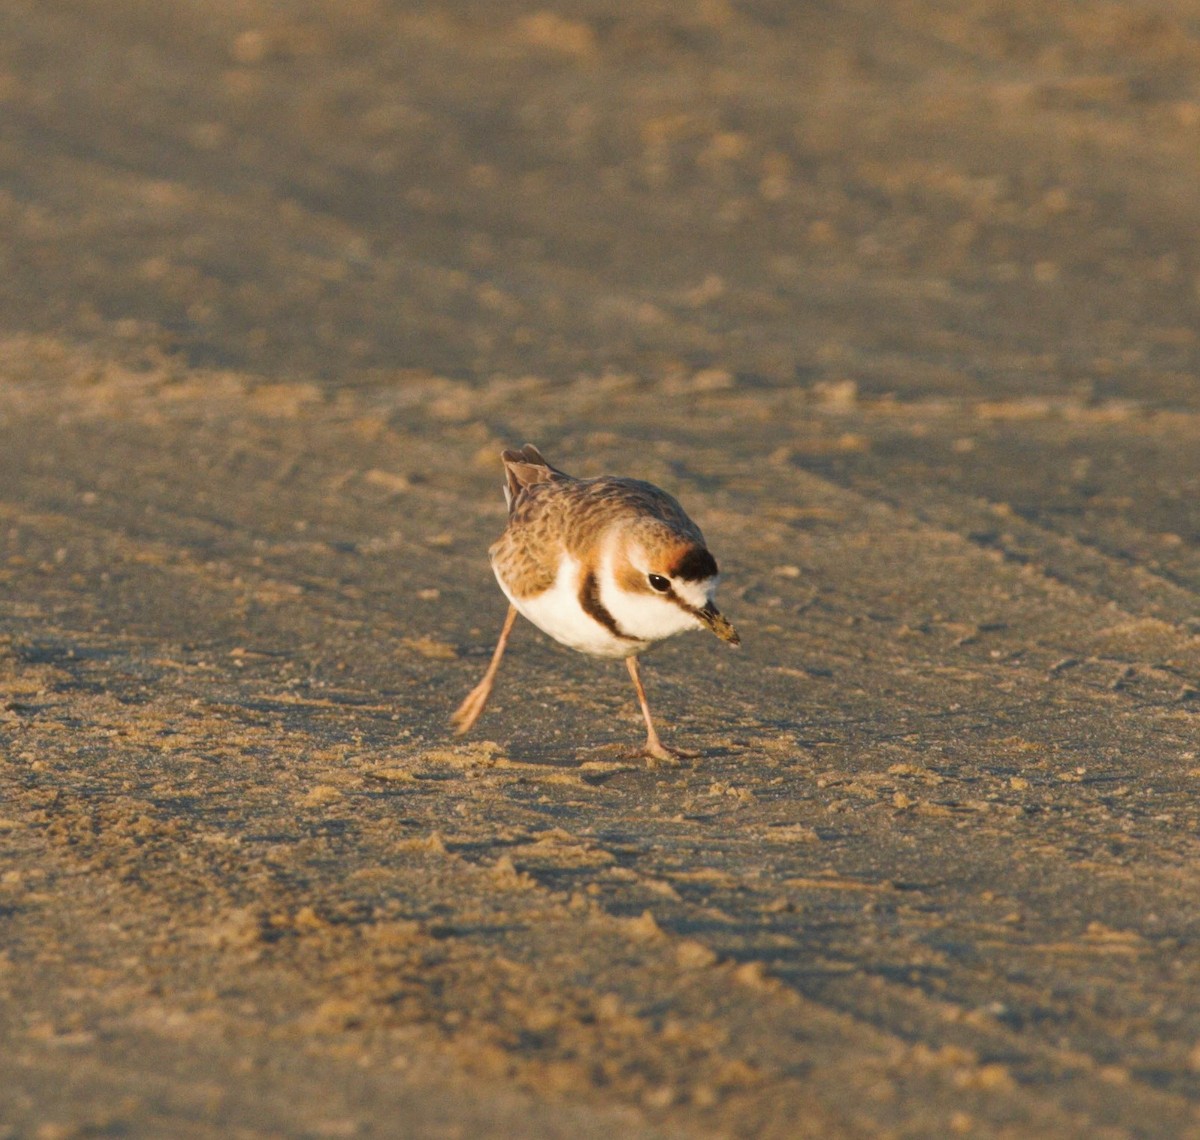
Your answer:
451,444 -> 740,760
